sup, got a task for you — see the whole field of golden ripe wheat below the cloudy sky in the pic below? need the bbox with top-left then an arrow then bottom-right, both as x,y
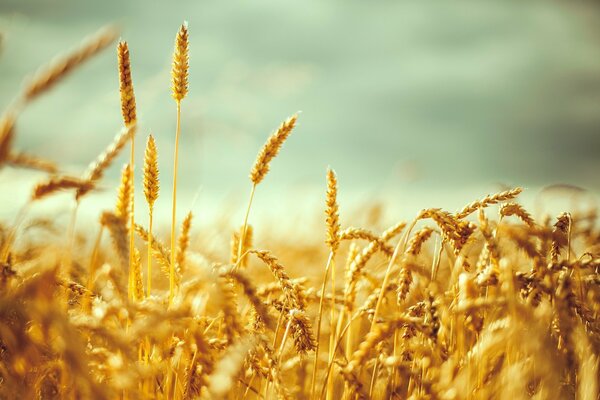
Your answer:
0,24 -> 600,400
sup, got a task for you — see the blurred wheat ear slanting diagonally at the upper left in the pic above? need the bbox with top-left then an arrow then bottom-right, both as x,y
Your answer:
23,26 -> 119,101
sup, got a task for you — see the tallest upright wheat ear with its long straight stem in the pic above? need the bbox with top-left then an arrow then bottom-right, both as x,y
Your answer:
169,22 -> 189,304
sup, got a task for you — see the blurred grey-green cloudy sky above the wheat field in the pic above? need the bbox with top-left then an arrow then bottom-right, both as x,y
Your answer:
0,0 -> 600,230
